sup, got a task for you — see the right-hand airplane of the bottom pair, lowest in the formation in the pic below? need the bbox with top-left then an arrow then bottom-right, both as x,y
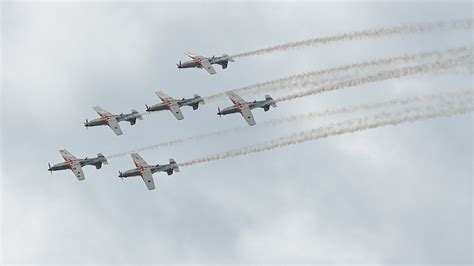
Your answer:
119,153 -> 179,190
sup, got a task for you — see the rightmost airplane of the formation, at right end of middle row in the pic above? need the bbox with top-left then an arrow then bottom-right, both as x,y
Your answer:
217,91 -> 276,126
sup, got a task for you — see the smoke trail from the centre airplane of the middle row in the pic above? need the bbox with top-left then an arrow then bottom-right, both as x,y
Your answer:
204,46 -> 473,103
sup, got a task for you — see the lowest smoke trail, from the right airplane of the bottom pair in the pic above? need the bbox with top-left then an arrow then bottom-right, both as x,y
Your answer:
180,101 -> 474,167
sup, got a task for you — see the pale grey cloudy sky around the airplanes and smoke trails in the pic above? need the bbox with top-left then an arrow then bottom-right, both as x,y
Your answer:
0,1 -> 473,265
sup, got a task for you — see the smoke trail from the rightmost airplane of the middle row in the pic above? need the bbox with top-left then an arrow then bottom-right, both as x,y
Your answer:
276,54 -> 473,102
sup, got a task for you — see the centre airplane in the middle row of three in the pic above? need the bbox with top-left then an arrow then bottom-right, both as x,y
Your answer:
146,91 -> 205,120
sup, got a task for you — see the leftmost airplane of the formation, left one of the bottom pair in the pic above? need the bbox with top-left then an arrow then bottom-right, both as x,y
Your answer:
48,150 -> 108,181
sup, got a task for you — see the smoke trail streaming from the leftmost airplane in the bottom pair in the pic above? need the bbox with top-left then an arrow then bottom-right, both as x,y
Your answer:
107,90 -> 473,159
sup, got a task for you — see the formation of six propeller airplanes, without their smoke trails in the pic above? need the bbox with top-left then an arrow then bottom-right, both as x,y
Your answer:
48,53 -> 276,190
